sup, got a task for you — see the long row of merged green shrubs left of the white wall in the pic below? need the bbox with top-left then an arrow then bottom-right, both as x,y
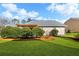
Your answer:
0,26 -> 44,38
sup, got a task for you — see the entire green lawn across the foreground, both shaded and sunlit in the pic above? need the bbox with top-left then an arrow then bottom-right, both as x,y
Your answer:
0,32 -> 79,56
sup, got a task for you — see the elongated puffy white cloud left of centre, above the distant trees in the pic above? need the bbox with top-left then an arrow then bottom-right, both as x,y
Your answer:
17,9 -> 39,19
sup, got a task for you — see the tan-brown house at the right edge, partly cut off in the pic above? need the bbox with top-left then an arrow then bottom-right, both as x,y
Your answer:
64,18 -> 79,32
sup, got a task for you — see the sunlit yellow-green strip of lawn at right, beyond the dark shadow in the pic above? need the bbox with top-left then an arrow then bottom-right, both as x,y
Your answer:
50,37 -> 79,49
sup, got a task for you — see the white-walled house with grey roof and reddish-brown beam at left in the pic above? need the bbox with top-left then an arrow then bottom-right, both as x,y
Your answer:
17,20 -> 65,35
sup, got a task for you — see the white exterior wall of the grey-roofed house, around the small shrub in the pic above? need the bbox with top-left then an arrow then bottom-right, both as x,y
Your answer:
42,27 -> 65,35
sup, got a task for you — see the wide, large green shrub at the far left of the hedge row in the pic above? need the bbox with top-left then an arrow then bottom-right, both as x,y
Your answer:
1,26 -> 21,38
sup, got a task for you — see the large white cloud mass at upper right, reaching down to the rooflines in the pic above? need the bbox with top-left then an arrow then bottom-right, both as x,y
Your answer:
47,3 -> 79,23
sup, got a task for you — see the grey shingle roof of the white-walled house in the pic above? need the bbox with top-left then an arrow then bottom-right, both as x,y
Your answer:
27,20 -> 64,27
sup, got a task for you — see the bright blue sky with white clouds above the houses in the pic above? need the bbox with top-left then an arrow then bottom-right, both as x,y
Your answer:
0,3 -> 79,23
